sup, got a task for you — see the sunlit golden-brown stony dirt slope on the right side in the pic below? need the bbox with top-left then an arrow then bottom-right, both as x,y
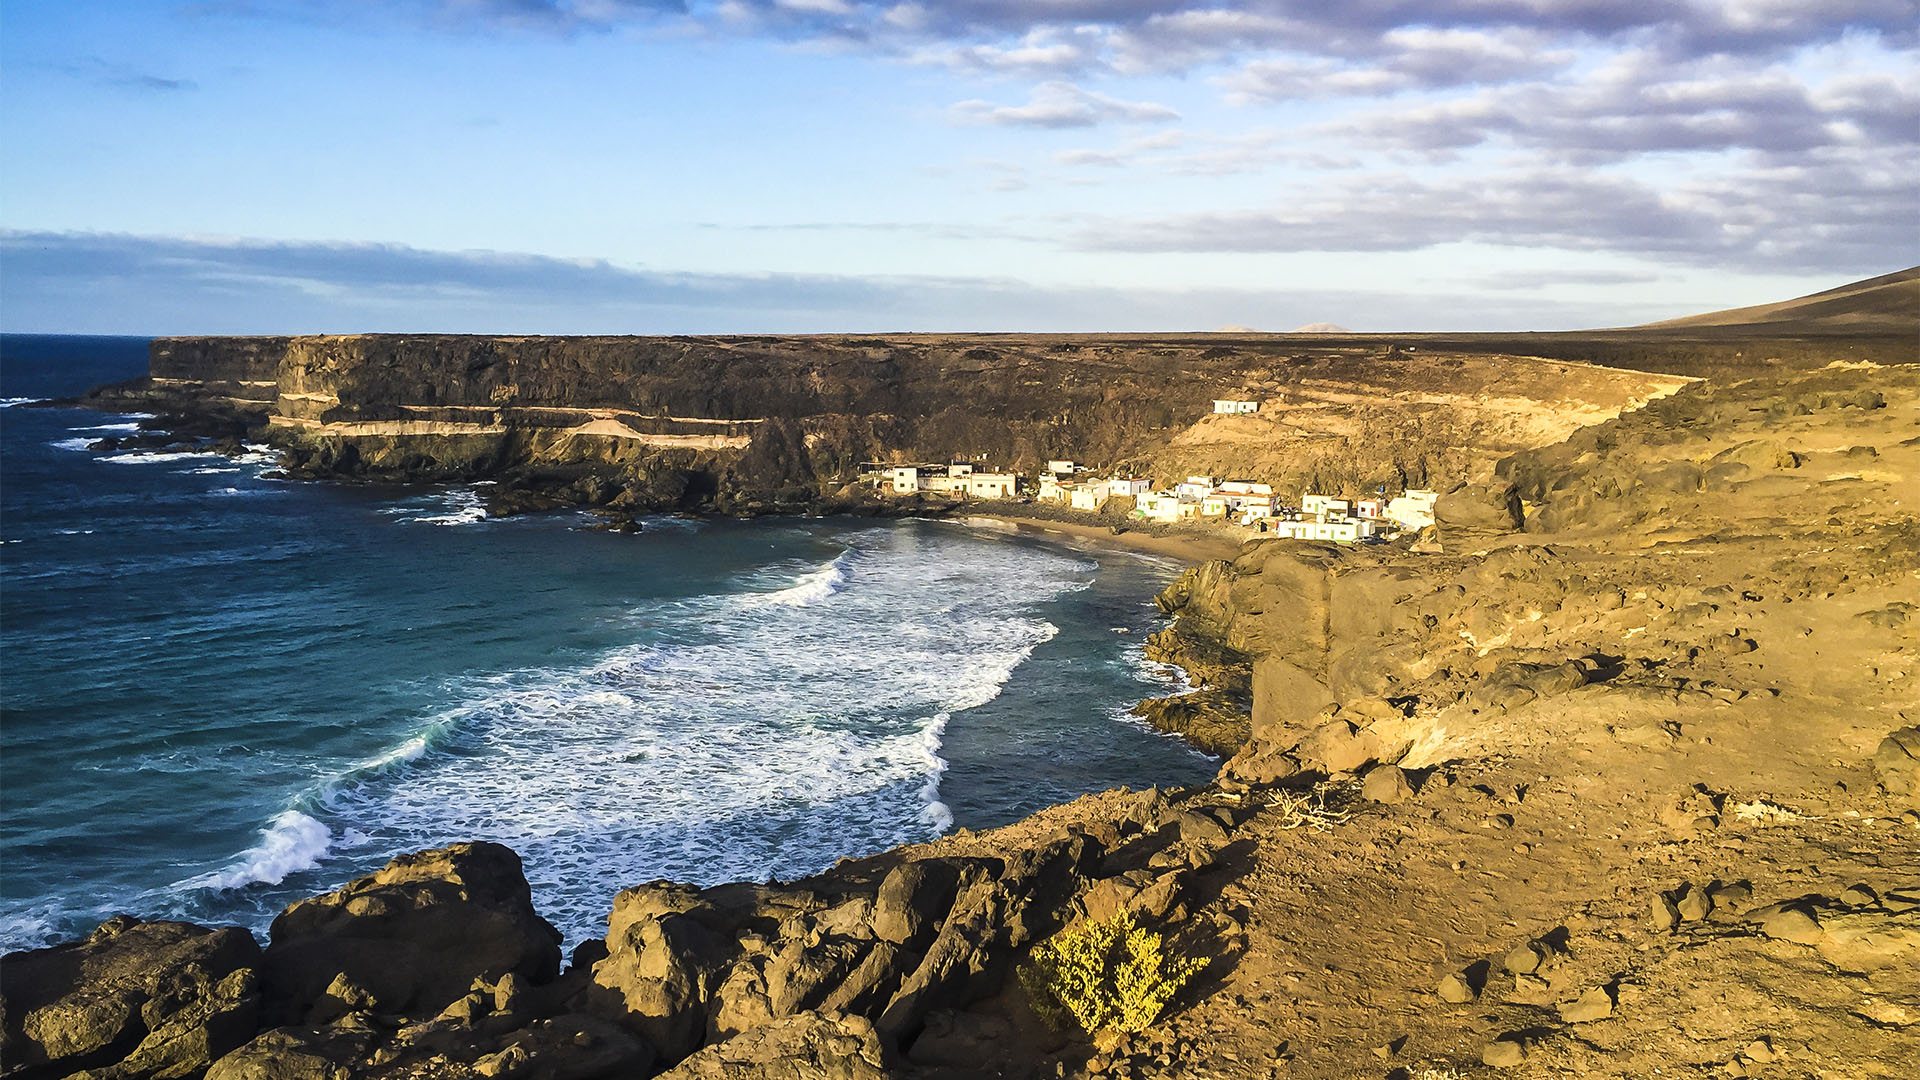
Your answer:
908,367 -> 1920,1080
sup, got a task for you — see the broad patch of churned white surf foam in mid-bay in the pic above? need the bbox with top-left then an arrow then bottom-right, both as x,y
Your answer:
297,527 -> 1089,940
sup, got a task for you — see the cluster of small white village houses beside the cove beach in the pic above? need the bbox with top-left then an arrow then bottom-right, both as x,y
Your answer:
862,400 -> 1440,544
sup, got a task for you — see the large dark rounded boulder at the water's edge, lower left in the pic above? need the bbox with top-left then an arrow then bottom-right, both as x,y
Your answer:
265,844 -> 561,1024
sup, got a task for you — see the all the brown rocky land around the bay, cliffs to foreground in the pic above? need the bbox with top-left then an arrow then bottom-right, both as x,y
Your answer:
0,271 -> 1920,1080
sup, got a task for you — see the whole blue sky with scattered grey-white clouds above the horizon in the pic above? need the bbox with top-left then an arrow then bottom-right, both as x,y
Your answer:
0,0 -> 1920,334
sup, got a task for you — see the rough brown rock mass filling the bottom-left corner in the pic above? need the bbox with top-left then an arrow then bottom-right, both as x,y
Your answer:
0,915 -> 259,1080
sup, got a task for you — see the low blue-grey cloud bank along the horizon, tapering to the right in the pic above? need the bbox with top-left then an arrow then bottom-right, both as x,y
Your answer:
0,233 -> 1684,334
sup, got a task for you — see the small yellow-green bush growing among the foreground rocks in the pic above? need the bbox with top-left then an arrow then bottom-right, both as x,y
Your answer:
1020,911 -> 1206,1034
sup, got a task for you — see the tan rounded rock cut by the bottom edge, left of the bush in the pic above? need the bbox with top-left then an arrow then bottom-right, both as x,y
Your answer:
659,1013 -> 889,1080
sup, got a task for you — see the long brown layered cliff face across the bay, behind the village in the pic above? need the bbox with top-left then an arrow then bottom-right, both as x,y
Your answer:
127,334 -> 1743,509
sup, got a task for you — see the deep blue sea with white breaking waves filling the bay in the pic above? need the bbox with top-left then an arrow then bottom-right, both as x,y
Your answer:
0,334 -> 1213,949
